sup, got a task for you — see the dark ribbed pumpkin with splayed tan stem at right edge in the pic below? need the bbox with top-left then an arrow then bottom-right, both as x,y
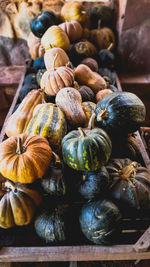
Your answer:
106,158 -> 150,209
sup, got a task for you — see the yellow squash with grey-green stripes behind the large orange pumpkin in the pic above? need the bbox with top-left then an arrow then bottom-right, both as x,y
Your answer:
26,103 -> 67,150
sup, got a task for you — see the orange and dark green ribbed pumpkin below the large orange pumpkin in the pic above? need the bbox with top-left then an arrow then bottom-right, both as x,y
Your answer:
0,181 -> 42,229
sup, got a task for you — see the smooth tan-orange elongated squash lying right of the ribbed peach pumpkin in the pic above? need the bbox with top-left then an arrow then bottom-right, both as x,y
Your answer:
74,64 -> 107,93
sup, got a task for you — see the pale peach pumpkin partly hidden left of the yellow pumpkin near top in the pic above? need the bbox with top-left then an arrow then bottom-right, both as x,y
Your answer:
27,32 -> 44,60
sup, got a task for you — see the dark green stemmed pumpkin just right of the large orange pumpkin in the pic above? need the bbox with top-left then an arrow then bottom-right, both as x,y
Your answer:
41,152 -> 66,197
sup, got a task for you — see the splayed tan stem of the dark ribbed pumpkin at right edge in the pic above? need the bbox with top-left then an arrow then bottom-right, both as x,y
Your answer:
119,161 -> 138,180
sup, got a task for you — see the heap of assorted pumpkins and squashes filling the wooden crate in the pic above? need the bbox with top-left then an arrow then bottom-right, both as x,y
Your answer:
0,1 -> 150,245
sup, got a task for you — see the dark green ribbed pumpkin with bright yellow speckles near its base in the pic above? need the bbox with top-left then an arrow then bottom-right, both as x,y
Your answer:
62,128 -> 112,171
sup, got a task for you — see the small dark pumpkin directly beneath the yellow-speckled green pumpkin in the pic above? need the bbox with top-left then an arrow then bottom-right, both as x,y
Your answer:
78,166 -> 109,200
